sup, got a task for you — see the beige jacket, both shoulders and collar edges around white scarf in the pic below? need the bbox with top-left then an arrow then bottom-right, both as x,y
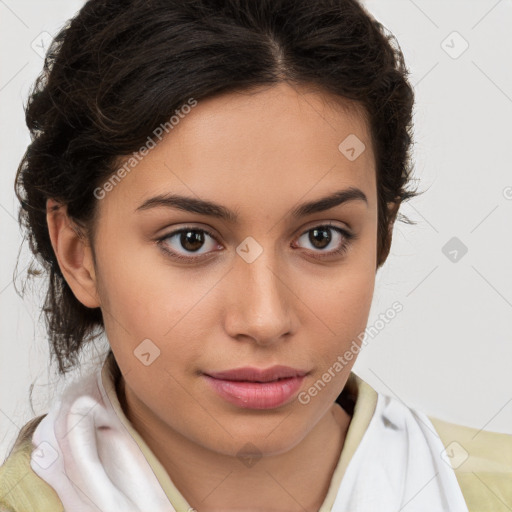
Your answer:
0,358 -> 512,512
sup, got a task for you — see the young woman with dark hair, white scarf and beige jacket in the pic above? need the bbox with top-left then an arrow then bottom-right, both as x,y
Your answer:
0,0 -> 512,512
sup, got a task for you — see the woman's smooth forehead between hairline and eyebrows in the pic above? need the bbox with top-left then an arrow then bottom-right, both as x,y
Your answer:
103,84 -> 376,216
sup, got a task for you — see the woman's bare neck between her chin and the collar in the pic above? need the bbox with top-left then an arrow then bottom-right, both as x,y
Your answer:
118,377 -> 351,512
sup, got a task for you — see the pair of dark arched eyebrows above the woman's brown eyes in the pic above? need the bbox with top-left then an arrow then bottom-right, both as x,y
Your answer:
135,187 -> 368,223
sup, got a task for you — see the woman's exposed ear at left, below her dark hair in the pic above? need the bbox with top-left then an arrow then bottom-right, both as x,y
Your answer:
46,199 -> 100,308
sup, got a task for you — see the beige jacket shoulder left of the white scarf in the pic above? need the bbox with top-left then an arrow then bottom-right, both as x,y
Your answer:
0,415 -> 64,512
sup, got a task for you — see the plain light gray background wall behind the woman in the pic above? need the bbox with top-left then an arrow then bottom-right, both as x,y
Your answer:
0,0 -> 512,460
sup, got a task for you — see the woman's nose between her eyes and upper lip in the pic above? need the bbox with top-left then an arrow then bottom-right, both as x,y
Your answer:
225,251 -> 296,345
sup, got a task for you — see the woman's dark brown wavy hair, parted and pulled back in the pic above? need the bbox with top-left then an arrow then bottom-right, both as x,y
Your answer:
15,0 -> 417,373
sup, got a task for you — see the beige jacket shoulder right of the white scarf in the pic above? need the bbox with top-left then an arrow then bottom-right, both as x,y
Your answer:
429,417 -> 512,512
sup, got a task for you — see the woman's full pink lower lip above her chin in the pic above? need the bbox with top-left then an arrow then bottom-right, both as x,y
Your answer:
204,375 -> 304,409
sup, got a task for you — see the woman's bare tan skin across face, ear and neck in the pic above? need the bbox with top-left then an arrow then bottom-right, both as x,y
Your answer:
48,84 -> 392,512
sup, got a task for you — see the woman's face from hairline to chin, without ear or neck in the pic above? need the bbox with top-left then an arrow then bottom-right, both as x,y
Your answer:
89,85 -> 377,455
